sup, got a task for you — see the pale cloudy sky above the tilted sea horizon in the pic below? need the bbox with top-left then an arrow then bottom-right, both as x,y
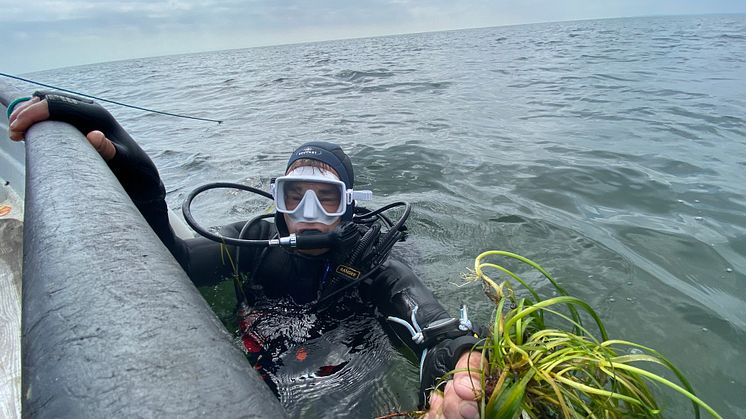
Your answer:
0,0 -> 746,75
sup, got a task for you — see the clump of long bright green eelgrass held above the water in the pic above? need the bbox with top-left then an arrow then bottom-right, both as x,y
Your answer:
460,251 -> 720,418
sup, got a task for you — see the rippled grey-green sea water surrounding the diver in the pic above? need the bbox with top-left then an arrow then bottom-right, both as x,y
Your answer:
20,15 -> 746,418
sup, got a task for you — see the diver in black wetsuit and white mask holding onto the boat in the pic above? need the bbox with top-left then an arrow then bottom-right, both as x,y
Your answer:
8,92 -> 482,418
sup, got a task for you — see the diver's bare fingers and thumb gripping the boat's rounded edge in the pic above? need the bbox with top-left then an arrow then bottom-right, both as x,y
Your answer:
8,96 -> 117,161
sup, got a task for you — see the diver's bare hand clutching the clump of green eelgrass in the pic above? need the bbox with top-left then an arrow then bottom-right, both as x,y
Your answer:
426,351 -> 482,419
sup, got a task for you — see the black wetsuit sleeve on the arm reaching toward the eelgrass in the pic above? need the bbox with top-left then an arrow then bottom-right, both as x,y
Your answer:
361,259 -> 479,406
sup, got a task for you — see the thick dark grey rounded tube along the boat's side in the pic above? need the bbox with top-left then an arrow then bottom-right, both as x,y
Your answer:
0,86 -> 285,418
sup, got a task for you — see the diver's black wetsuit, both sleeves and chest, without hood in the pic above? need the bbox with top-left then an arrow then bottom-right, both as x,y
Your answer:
35,92 -> 476,401
